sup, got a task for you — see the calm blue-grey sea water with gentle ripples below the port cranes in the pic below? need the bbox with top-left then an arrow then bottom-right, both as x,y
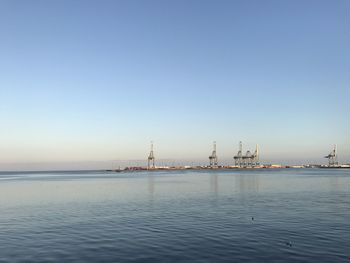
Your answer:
0,169 -> 350,262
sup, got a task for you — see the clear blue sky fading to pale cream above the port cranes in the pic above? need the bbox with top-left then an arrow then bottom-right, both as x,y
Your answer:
0,0 -> 350,168
